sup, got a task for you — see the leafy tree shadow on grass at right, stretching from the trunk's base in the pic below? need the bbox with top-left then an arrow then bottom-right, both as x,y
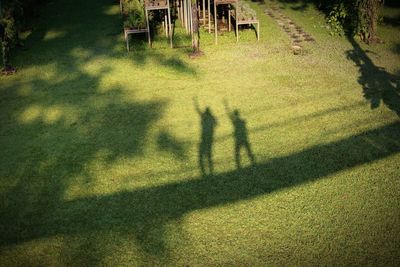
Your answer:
346,36 -> 400,116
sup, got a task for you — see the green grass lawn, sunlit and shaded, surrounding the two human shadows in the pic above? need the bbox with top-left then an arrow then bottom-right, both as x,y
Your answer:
0,0 -> 400,266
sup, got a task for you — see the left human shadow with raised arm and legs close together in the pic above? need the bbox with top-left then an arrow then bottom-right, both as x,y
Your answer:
193,98 -> 217,176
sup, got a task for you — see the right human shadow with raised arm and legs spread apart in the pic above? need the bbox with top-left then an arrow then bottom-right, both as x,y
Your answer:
224,100 -> 255,169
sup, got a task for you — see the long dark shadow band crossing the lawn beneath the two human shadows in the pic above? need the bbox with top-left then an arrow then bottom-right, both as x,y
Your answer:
1,122 -> 400,256
